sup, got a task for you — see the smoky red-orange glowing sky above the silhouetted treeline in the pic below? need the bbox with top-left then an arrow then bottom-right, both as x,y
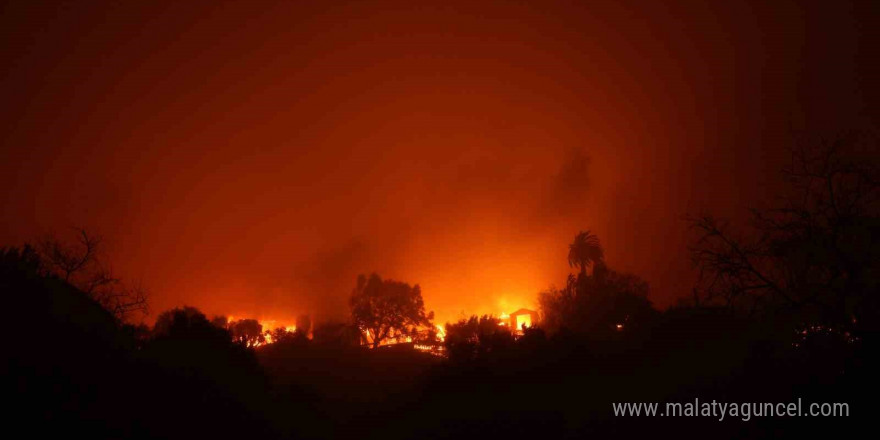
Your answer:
0,1 -> 880,322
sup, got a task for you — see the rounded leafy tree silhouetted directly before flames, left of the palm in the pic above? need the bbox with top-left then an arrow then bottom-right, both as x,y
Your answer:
349,273 -> 434,348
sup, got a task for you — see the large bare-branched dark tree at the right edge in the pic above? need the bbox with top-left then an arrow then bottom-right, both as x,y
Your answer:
690,134 -> 880,328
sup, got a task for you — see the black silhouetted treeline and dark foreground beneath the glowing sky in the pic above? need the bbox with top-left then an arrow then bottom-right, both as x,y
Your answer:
0,136 -> 880,439
